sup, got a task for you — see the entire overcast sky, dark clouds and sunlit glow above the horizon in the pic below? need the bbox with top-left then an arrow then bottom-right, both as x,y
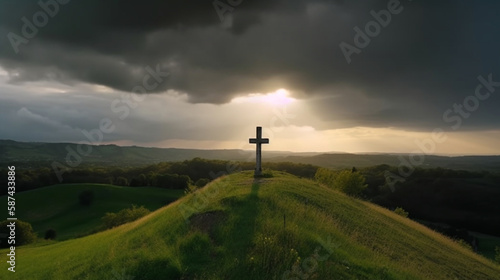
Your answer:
0,0 -> 500,154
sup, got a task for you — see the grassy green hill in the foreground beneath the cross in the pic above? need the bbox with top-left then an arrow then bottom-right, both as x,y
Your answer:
0,172 -> 500,280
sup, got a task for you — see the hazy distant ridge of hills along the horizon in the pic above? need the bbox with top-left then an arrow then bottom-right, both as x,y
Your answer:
0,140 -> 500,172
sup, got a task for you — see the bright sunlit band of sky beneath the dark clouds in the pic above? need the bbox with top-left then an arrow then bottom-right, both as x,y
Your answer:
0,79 -> 499,154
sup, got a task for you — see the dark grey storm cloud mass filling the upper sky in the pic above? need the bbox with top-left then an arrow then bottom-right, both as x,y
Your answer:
0,0 -> 500,130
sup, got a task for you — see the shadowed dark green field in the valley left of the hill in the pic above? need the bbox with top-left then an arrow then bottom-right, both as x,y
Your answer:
0,184 -> 183,240
